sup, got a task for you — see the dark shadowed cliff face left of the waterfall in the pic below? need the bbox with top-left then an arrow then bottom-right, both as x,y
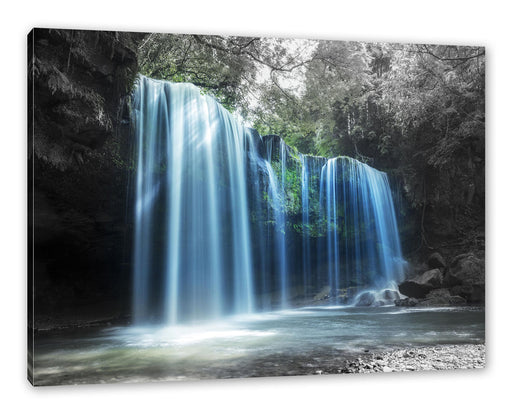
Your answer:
28,29 -> 144,326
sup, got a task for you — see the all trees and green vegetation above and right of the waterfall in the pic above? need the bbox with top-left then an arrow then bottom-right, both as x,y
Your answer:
139,34 -> 485,249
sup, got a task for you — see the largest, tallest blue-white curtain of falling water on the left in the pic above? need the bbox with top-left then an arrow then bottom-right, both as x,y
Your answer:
133,77 -> 254,324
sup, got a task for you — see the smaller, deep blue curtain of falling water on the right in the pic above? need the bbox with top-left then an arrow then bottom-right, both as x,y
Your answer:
320,157 -> 403,298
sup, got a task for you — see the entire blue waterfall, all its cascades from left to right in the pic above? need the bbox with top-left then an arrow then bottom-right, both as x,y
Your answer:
133,76 -> 402,324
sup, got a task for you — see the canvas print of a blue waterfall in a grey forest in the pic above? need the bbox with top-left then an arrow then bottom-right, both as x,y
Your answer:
28,29 -> 485,386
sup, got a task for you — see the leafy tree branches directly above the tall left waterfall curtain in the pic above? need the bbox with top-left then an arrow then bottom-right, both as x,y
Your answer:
139,34 -> 309,117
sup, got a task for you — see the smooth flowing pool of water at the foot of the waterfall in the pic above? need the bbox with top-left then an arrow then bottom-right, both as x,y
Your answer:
34,306 -> 485,385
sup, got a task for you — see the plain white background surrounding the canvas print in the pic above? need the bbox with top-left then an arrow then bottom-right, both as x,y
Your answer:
0,0 -> 512,414
